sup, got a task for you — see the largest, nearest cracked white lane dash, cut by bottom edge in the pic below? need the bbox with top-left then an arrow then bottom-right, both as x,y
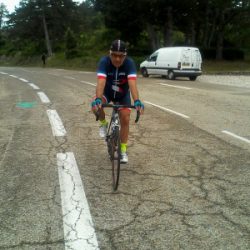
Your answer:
57,152 -> 99,250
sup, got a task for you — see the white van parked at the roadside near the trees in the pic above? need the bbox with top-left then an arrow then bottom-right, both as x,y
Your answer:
140,47 -> 202,81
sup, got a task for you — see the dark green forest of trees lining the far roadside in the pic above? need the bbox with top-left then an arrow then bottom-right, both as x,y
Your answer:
0,0 -> 250,64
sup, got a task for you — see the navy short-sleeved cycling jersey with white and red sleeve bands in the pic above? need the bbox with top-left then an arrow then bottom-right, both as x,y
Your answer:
97,56 -> 136,102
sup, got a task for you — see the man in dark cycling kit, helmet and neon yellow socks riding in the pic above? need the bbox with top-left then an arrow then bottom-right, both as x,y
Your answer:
91,40 -> 144,163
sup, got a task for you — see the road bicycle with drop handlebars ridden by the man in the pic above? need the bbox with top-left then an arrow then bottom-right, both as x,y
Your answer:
96,104 -> 140,191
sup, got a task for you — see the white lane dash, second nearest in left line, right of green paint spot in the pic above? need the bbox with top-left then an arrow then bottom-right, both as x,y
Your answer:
47,109 -> 66,136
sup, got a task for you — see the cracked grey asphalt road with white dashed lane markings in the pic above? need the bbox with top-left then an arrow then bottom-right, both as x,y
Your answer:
0,67 -> 250,250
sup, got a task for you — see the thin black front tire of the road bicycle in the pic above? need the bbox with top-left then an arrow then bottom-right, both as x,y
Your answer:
110,127 -> 121,191
